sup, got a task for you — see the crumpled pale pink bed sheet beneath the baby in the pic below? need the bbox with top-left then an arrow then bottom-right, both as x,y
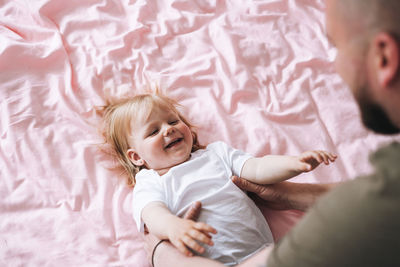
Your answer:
0,0 -> 393,267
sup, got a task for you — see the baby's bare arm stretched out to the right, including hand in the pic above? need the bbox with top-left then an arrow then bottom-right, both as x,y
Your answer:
240,151 -> 337,184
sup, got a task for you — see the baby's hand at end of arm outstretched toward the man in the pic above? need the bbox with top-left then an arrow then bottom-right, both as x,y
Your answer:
297,150 -> 337,172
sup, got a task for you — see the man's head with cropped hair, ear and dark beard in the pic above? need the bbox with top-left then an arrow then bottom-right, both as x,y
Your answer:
326,0 -> 400,134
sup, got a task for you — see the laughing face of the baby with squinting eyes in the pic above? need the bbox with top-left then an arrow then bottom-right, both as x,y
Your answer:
126,108 -> 193,175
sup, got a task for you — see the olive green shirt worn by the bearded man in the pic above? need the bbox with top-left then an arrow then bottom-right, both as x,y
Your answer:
267,143 -> 400,267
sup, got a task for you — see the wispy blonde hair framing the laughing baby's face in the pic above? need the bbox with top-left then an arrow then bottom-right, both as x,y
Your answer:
101,90 -> 204,186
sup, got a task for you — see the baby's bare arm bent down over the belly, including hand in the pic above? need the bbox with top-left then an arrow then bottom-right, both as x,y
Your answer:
142,202 -> 217,256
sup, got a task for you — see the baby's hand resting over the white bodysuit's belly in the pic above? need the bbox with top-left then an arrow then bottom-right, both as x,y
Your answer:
168,217 -> 217,256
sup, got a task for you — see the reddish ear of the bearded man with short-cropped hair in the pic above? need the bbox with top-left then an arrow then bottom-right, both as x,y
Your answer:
373,32 -> 399,88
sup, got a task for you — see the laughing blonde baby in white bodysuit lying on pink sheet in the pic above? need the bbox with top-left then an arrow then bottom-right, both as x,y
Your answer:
104,93 -> 336,265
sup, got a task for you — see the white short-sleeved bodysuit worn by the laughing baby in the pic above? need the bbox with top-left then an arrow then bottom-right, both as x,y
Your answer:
133,142 -> 273,265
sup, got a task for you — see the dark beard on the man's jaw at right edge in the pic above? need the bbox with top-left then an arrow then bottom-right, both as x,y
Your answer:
356,85 -> 400,134
